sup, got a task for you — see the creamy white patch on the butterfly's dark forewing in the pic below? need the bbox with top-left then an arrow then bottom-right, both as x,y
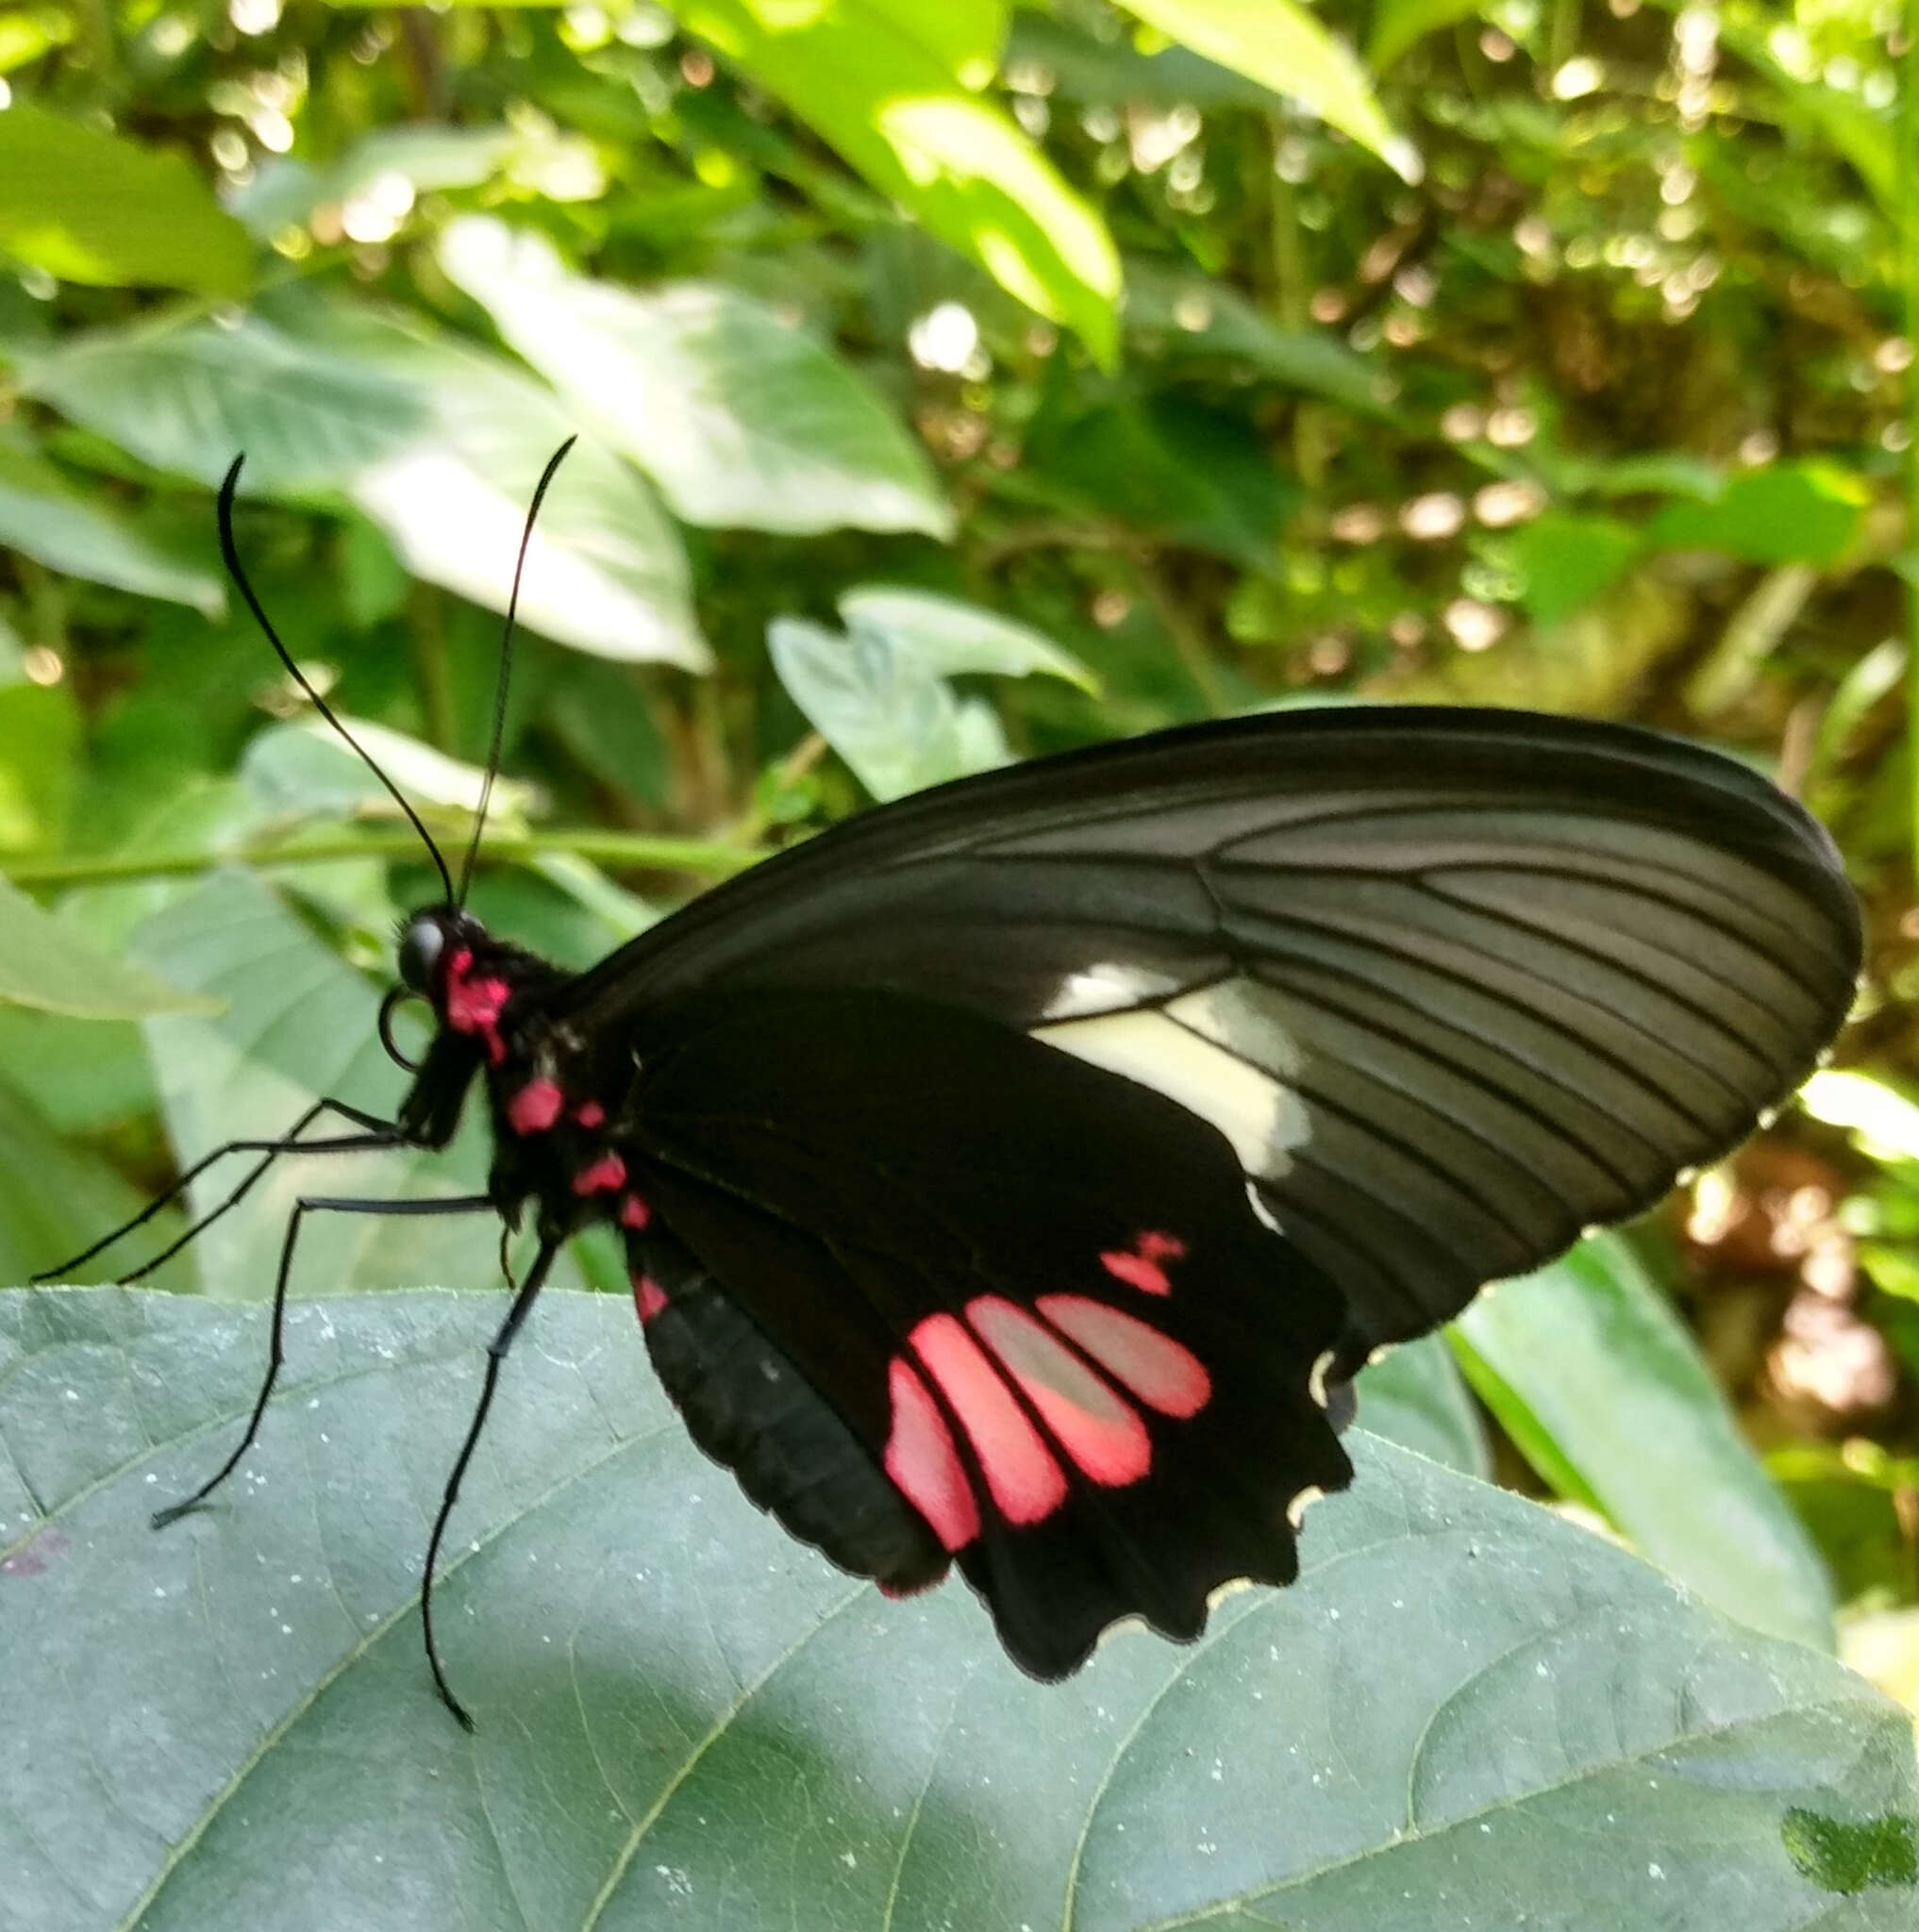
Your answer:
1032,988 -> 1312,1176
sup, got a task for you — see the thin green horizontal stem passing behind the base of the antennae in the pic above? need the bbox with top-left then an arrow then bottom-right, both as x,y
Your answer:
0,824 -> 767,887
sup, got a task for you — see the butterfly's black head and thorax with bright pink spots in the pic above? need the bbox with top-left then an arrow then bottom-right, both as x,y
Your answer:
400,908 -> 645,1237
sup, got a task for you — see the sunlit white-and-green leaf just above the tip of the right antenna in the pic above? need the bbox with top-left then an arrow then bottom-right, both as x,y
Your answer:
439,214 -> 953,537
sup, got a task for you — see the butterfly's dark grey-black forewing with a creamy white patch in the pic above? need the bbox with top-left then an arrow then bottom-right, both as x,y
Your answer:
562,708 -> 1860,1372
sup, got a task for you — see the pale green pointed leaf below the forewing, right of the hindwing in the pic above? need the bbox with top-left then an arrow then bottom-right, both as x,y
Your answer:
1453,1235 -> 1832,1648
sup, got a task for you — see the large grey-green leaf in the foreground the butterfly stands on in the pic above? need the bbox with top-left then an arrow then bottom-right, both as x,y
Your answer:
0,1292 -> 1919,1932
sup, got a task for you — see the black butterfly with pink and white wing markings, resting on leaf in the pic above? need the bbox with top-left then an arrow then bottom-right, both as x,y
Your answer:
52,452 -> 1860,1722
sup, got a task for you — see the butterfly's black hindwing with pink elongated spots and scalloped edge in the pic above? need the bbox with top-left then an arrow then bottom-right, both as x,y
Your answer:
618,991 -> 1351,1677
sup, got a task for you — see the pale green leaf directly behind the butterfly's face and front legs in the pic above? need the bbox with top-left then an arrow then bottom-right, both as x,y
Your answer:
122,874 -> 572,1300
